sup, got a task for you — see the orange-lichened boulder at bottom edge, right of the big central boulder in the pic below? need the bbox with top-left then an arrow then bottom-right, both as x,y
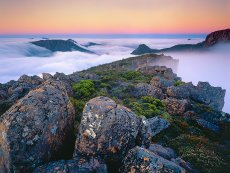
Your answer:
120,147 -> 185,173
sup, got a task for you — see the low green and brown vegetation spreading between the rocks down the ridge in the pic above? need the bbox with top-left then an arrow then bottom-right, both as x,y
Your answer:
71,70 -> 230,173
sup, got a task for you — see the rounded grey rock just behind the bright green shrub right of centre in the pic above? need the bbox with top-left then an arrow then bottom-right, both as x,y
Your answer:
132,83 -> 164,99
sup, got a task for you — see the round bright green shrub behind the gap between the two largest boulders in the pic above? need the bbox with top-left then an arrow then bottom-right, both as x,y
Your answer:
73,80 -> 96,99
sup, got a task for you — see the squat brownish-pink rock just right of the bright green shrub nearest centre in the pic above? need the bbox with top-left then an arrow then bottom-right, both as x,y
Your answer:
163,98 -> 189,116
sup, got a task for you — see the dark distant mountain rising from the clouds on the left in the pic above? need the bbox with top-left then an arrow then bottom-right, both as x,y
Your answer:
31,39 -> 93,53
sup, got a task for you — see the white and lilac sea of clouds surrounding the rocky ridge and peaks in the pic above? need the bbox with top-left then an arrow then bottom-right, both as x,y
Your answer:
0,38 -> 230,112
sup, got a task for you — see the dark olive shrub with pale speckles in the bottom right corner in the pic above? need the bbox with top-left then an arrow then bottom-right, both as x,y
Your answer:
169,135 -> 227,173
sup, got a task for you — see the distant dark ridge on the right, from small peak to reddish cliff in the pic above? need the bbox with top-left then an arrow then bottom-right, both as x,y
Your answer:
131,29 -> 230,55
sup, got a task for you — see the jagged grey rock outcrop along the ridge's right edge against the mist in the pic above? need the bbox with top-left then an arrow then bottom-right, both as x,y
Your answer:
141,66 -> 226,111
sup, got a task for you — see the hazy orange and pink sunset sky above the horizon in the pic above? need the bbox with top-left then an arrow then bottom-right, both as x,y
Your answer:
0,0 -> 230,35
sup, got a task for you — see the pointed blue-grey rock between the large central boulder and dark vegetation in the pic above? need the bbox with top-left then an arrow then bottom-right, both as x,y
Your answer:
148,117 -> 170,137
